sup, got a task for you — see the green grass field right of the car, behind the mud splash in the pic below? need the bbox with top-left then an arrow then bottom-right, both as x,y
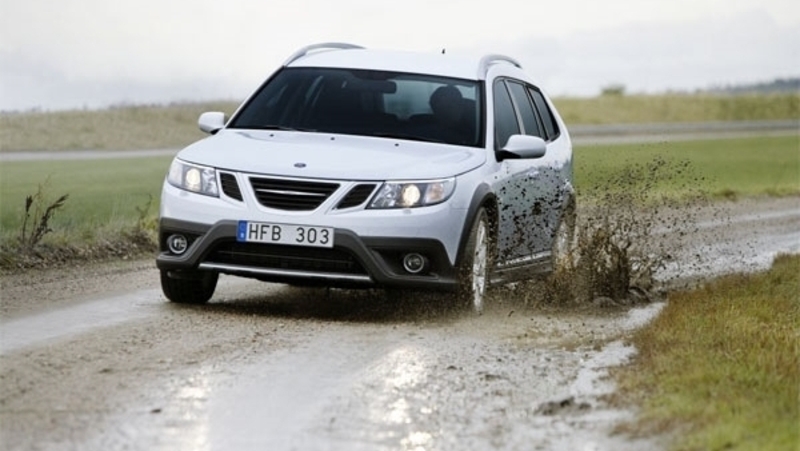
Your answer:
574,136 -> 800,198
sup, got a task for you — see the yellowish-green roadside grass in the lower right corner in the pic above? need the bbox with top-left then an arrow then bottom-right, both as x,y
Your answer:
616,255 -> 800,451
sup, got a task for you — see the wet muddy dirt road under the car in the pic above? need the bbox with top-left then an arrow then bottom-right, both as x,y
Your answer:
0,198 -> 800,451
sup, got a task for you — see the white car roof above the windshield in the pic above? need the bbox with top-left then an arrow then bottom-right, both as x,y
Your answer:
286,47 -> 518,80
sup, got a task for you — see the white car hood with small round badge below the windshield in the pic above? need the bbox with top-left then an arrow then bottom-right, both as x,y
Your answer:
178,130 -> 486,180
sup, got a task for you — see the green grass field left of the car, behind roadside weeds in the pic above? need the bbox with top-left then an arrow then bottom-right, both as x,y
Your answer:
0,157 -> 171,241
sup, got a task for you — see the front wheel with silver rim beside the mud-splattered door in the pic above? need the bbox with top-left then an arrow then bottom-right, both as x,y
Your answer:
457,208 -> 492,314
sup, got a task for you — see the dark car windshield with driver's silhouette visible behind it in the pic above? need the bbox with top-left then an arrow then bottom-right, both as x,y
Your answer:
229,68 -> 482,146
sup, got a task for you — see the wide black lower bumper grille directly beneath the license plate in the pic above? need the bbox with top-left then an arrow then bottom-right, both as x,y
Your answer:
206,242 -> 367,275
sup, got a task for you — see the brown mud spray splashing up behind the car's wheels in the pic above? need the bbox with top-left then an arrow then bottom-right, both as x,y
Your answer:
503,157 -> 711,306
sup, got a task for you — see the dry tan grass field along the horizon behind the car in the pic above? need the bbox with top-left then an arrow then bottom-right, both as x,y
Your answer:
0,94 -> 800,152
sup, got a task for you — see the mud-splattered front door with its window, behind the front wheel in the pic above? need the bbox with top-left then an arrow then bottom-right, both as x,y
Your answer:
493,79 -> 554,267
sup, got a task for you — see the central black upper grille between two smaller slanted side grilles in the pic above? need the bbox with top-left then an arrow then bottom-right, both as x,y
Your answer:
250,177 -> 339,211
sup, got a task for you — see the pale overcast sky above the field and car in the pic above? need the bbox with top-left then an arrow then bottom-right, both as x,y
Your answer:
0,0 -> 800,111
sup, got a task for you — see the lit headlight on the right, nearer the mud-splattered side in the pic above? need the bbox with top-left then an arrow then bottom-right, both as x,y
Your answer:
369,178 -> 456,208
